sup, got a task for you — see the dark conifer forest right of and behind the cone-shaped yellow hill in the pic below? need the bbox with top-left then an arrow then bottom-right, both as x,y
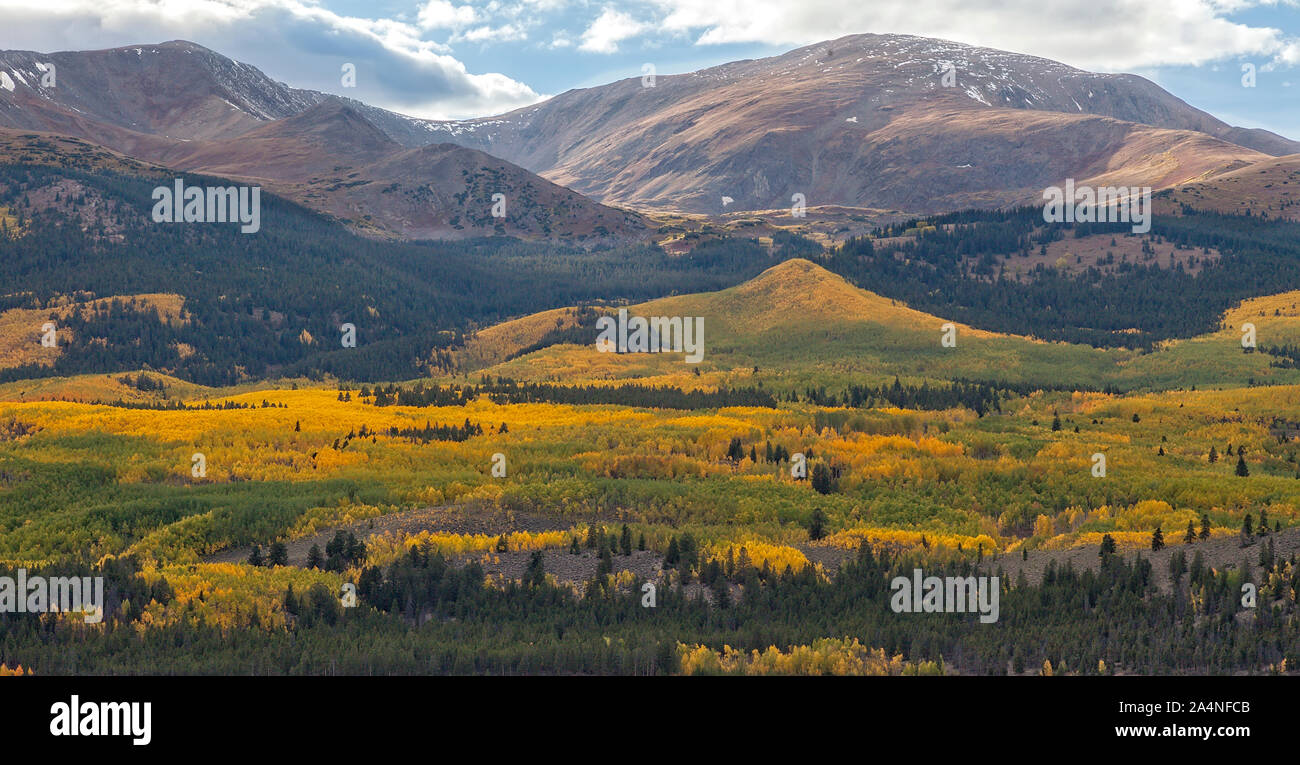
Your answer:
827,207 -> 1300,349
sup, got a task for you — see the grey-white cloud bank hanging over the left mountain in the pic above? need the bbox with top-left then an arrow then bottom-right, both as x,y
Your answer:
0,0 -> 541,118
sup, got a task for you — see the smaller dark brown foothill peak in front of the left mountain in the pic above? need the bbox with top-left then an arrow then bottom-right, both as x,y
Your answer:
156,99 -> 645,241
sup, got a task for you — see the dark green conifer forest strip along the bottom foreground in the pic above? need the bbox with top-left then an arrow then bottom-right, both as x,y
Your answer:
0,544 -> 1300,675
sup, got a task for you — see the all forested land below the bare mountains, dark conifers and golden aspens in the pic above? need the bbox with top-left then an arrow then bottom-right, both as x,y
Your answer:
0,167 -> 1300,675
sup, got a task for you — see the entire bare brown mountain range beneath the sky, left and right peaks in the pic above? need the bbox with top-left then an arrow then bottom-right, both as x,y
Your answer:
0,35 -> 1300,230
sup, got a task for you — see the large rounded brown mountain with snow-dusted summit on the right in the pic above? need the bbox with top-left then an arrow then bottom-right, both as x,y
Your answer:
408,35 -> 1300,213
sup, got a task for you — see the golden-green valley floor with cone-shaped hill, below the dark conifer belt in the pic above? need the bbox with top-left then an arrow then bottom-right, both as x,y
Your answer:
0,260 -> 1300,674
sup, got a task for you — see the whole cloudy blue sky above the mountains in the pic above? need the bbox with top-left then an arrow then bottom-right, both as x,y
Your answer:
0,0 -> 1300,139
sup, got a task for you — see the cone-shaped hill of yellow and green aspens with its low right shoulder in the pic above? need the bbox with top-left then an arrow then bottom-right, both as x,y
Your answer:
467,259 -> 1300,389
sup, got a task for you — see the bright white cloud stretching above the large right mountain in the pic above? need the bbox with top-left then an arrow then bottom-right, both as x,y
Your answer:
650,0 -> 1297,72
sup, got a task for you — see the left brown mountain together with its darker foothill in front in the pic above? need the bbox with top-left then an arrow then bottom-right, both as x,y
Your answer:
0,42 -> 645,242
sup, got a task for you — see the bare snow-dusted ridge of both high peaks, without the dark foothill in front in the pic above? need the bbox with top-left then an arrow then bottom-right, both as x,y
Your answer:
0,35 -> 1300,221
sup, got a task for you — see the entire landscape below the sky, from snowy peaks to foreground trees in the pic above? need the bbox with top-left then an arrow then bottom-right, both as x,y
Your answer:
0,26 -> 1300,675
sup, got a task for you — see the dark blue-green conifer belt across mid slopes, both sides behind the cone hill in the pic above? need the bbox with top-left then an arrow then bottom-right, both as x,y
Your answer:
0,165 -> 1300,385
